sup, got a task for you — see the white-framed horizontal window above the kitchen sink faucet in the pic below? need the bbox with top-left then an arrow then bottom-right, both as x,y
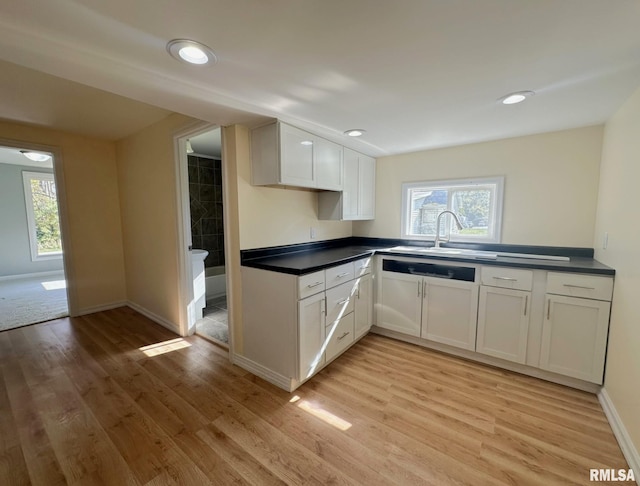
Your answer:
402,177 -> 504,243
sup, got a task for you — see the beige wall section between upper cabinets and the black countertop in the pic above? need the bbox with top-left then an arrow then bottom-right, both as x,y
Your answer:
238,125 -> 352,250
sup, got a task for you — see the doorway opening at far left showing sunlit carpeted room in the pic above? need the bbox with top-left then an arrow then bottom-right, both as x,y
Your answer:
0,145 -> 69,331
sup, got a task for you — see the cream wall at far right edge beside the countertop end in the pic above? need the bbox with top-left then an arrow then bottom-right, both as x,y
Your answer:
594,89 -> 640,460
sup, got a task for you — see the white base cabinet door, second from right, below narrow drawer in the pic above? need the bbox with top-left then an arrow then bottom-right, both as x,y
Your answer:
476,285 -> 531,363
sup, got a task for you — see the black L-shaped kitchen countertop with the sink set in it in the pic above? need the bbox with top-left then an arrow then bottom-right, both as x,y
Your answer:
241,237 -> 615,276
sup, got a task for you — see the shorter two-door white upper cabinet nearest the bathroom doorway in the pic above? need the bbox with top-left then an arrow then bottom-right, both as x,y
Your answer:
251,122 -> 343,191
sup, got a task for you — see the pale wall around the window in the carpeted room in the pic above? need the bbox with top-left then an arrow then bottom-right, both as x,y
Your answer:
0,161 -> 62,277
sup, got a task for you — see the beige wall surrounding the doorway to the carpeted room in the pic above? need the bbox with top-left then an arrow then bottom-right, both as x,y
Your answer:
0,122 -> 126,314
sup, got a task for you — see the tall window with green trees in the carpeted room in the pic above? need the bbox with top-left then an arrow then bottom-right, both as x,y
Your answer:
22,172 -> 62,261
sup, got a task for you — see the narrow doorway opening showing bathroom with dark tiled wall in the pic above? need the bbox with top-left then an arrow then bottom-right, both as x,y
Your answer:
185,128 -> 229,348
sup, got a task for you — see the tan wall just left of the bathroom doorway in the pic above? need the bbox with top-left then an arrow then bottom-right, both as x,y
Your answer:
116,114 -> 195,331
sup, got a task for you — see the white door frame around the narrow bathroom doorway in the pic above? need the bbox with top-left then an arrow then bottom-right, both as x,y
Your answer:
174,122 -> 233,355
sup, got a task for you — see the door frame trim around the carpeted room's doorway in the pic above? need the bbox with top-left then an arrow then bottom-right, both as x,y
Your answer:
0,138 -> 78,316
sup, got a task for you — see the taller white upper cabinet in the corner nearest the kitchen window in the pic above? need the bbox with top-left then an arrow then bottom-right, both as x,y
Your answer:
318,147 -> 376,220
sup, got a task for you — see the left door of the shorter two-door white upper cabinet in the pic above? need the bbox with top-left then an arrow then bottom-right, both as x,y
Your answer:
280,123 -> 315,187
